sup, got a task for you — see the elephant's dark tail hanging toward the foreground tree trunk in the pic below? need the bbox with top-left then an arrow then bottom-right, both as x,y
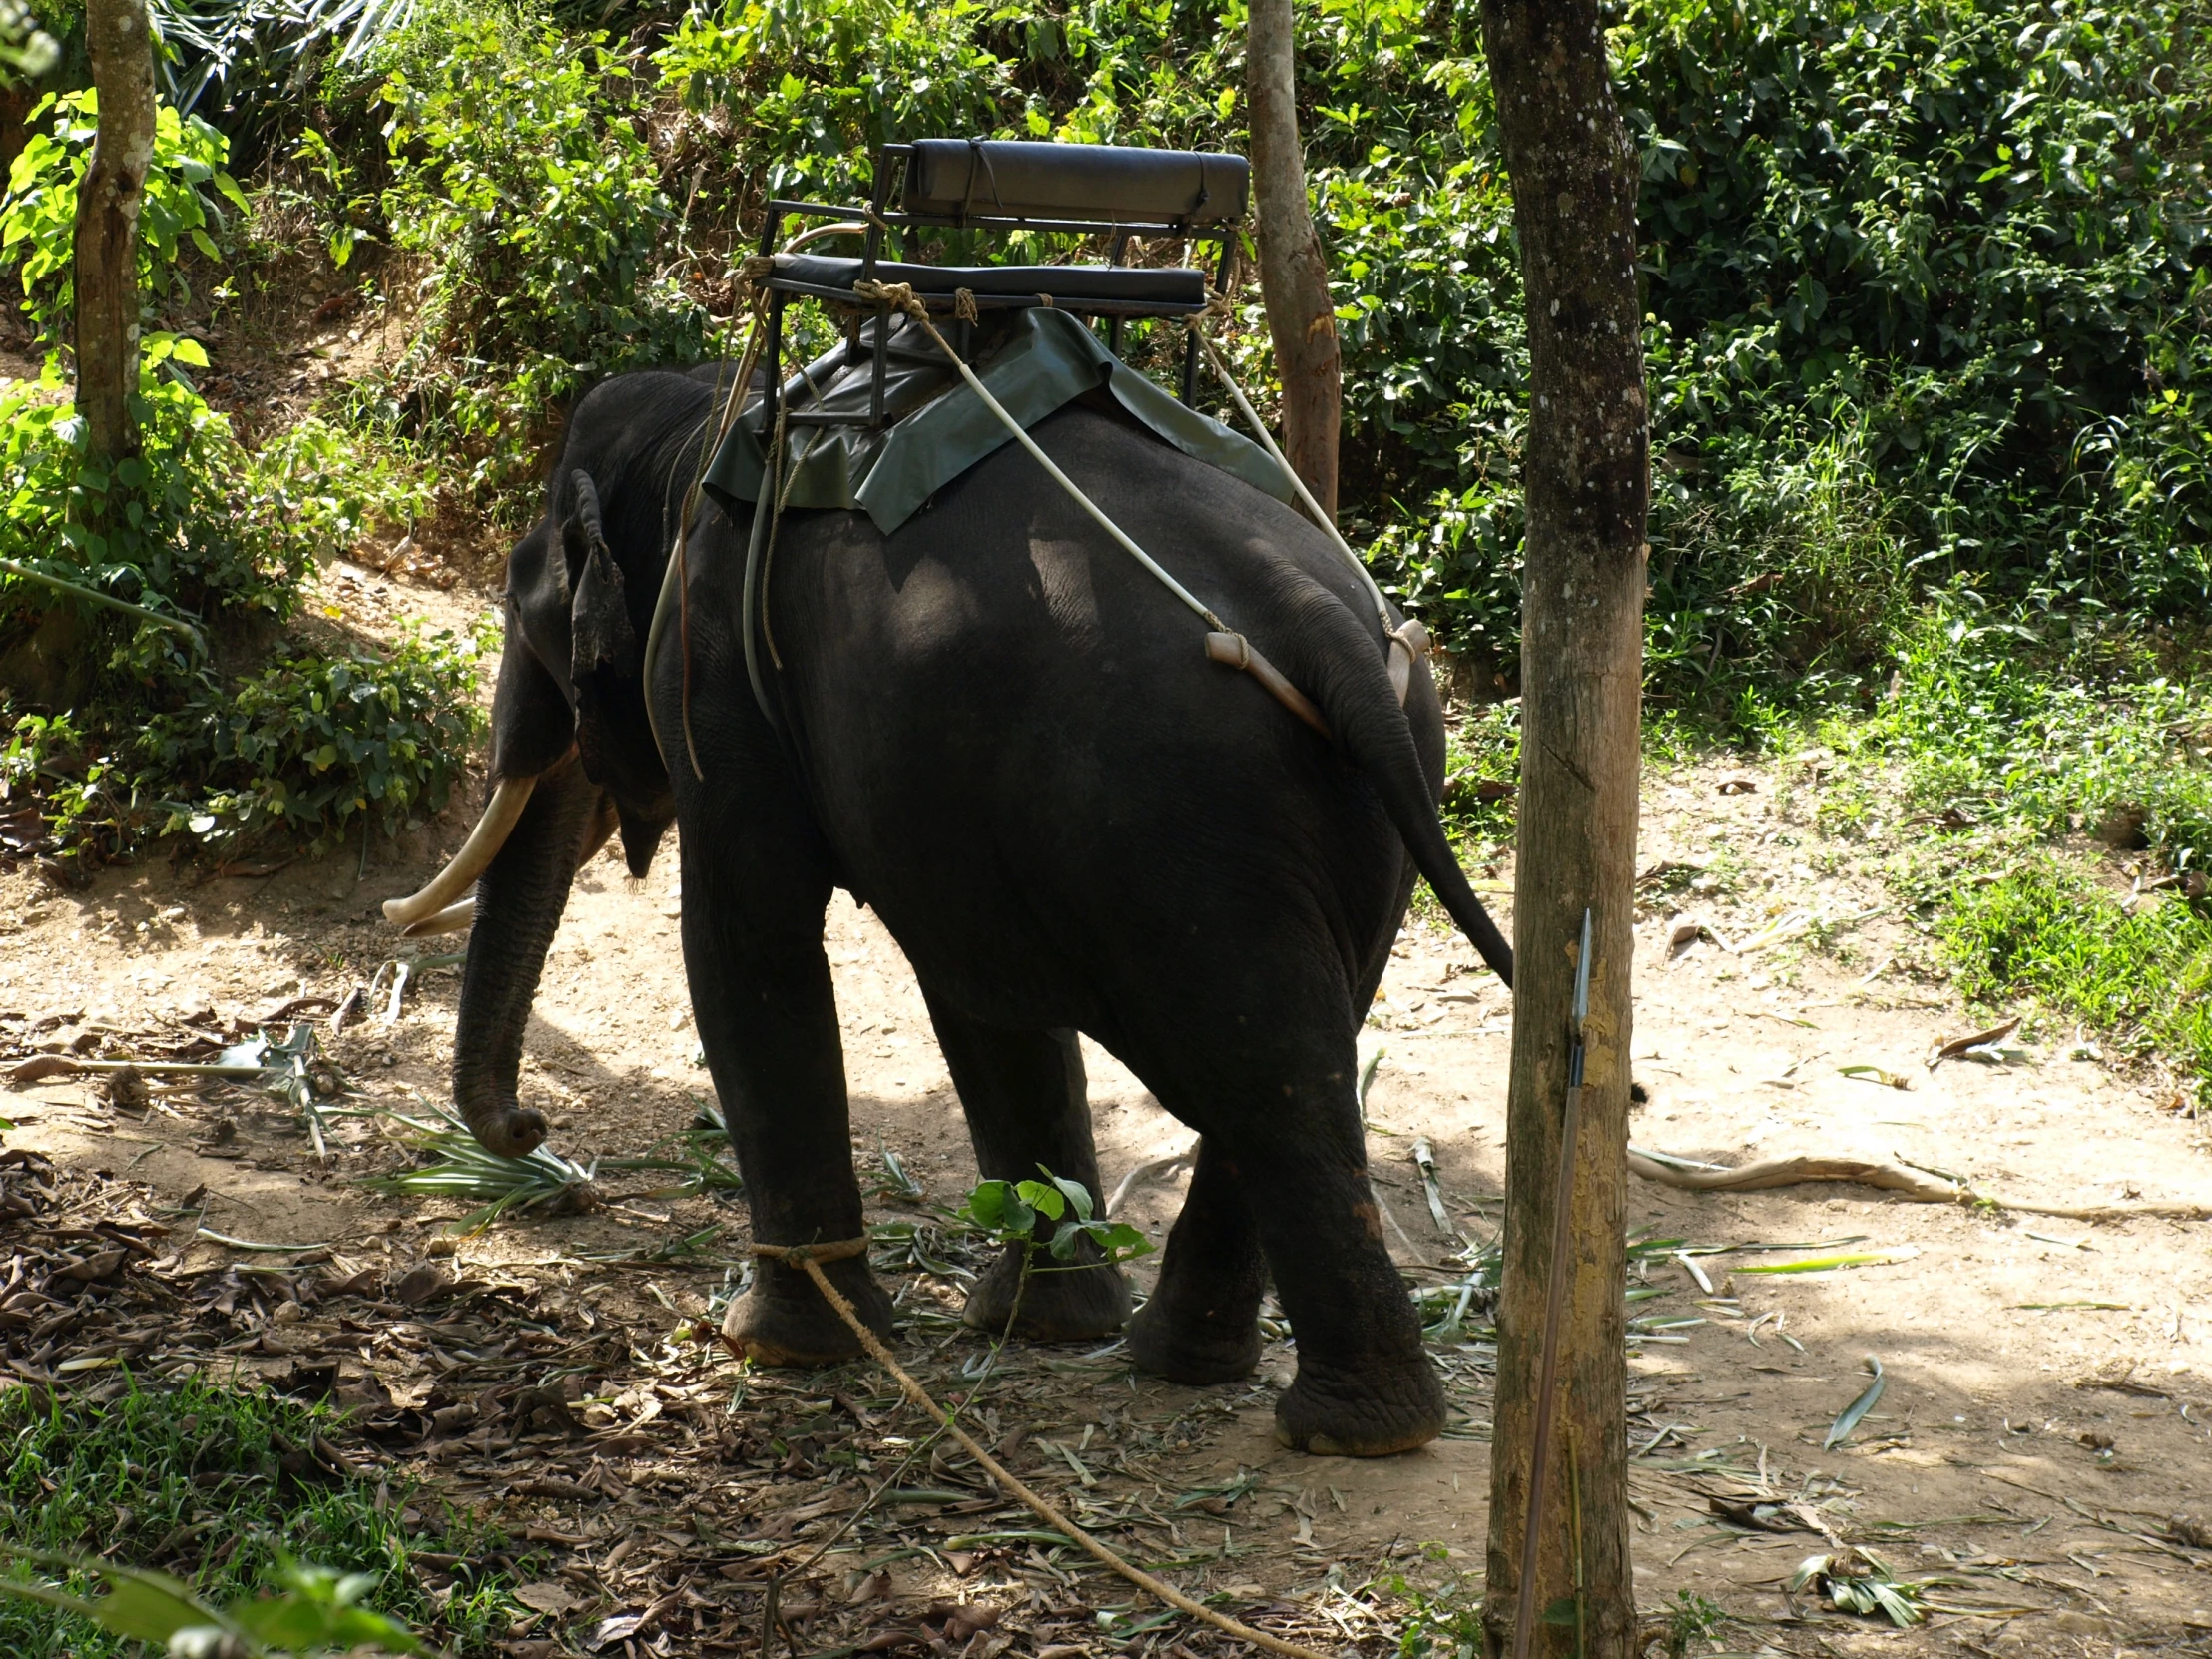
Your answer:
1283,575 -> 1513,989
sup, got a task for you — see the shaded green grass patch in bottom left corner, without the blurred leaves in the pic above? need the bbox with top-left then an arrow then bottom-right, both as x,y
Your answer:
0,1381 -> 520,1659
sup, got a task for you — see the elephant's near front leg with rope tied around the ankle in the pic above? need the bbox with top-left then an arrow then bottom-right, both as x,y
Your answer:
682,779 -> 891,1365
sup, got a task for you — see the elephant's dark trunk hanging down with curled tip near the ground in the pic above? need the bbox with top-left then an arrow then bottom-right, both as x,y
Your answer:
453,755 -> 613,1157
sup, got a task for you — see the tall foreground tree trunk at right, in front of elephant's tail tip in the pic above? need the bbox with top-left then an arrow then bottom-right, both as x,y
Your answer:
1482,0 -> 1650,1659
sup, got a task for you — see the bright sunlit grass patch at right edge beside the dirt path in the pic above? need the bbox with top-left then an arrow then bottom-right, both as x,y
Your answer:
1937,862 -> 2212,1108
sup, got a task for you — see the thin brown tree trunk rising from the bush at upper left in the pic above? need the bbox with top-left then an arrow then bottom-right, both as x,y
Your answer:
71,0 -> 155,462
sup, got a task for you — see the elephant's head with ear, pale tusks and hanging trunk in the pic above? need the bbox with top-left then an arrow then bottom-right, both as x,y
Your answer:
385,374 -> 713,1157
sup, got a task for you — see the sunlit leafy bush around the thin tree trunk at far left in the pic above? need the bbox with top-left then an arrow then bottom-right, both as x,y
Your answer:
0,95 -> 482,871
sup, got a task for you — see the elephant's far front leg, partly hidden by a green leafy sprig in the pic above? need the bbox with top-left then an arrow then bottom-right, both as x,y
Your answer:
922,986 -> 1128,1343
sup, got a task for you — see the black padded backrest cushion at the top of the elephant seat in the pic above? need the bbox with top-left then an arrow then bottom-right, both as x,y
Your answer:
907,140 -> 1252,226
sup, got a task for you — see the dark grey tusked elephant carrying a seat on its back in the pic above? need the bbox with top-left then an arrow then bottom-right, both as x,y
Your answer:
389,362 -> 1511,1455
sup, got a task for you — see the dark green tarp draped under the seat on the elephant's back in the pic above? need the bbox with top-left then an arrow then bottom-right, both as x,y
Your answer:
704,305 -> 1292,535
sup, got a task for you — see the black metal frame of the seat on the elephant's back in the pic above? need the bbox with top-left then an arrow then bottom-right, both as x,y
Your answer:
759,144 -> 1241,437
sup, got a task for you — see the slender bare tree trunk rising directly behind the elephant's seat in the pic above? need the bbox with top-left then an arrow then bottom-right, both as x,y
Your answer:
1246,0 -> 1343,518
